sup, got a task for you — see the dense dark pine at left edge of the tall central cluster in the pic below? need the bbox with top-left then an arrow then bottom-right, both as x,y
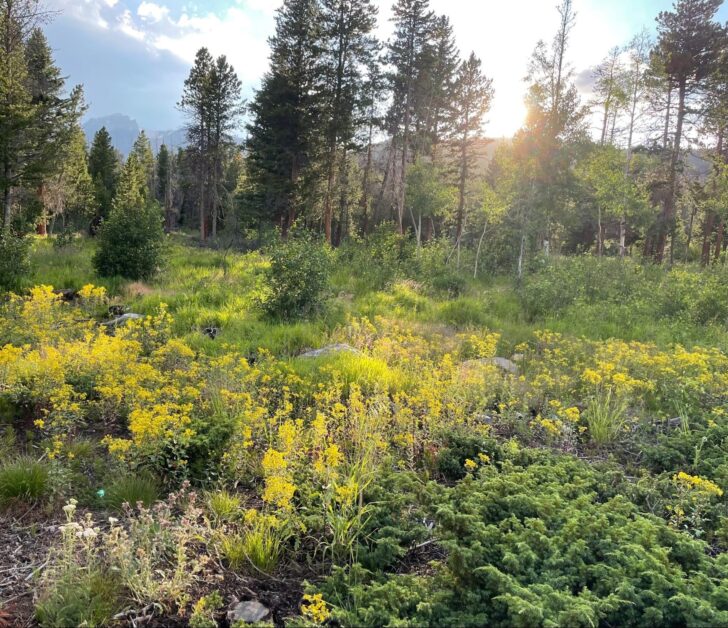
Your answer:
241,0 -> 321,237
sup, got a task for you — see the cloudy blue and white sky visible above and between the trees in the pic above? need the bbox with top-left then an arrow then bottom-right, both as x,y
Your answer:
45,0 -> 728,137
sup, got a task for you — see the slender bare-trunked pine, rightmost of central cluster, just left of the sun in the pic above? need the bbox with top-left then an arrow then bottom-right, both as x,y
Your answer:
450,53 -> 493,247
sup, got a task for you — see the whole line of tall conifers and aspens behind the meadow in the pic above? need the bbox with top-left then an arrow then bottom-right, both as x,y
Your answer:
0,0 -> 728,274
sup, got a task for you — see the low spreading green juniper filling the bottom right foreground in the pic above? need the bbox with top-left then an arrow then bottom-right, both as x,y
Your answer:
321,449 -> 728,626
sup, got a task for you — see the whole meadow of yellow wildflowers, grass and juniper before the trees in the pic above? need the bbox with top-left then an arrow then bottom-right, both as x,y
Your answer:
0,230 -> 728,628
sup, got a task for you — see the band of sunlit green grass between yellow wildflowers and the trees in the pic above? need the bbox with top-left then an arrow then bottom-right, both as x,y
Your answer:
28,234 -> 728,357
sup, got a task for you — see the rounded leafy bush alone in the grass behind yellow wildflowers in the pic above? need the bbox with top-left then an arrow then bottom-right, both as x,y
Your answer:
265,236 -> 332,319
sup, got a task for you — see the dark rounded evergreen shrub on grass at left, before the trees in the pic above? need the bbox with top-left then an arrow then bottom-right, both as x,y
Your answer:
93,204 -> 165,280
